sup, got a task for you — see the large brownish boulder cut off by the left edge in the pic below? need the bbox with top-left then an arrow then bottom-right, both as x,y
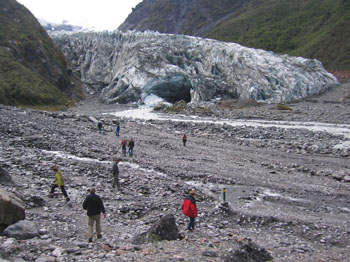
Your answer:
0,188 -> 25,232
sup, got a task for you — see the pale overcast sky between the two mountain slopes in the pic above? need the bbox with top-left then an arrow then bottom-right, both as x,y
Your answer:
17,0 -> 142,30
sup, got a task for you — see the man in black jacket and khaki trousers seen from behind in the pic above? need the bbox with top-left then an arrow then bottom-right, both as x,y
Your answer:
83,187 -> 107,242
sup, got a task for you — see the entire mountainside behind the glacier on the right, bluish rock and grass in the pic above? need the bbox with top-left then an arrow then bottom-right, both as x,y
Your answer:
119,0 -> 350,70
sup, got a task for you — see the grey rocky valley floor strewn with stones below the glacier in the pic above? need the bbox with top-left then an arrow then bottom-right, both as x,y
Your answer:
0,83 -> 350,262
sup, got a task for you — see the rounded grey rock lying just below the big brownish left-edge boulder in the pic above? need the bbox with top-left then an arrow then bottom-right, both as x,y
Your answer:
3,220 -> 39,239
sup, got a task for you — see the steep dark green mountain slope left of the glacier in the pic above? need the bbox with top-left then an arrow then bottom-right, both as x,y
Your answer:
0,0 -> 81,106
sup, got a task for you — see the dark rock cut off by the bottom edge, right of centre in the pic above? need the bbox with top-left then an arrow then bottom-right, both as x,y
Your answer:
222,241 -> 273,262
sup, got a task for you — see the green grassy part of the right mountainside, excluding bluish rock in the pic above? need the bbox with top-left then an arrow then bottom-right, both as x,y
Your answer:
208,0 -> 350,70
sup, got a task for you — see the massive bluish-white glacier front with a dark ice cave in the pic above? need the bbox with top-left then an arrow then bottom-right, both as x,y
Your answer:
53,31 -> 338,103
